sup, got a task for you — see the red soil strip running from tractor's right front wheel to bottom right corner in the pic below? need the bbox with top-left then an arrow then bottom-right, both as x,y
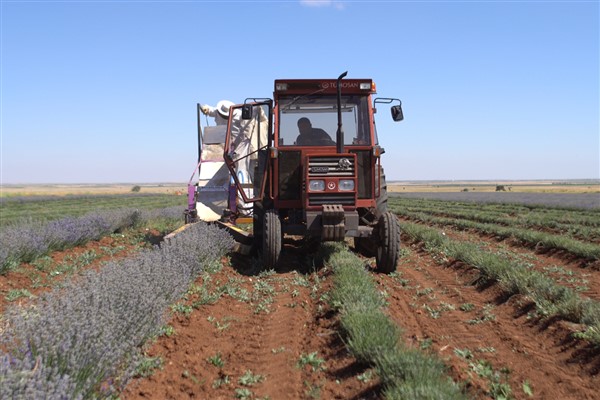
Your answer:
376,233 -> 600,399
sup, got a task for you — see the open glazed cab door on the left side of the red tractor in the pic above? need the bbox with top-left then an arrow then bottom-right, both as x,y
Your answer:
223,101 -> 272,203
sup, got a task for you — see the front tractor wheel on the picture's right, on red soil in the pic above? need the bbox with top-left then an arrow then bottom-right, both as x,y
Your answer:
375,211 -> 400,274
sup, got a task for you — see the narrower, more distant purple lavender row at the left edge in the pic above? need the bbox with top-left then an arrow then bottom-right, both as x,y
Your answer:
0,206 -> 181,273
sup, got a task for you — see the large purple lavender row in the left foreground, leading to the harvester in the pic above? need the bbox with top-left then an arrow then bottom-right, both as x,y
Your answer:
0,224 -> 233,399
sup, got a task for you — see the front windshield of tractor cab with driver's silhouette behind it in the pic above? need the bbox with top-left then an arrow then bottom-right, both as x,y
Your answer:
278,94 -> 371,146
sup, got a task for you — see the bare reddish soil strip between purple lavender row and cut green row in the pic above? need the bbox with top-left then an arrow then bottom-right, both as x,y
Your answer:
121,242 -> 378,400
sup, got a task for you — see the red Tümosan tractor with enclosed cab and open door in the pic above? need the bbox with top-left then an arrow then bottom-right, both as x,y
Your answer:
186,73 -> 403,273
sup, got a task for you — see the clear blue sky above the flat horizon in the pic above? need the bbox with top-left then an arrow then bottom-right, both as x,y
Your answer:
0,0 -> 600,184
